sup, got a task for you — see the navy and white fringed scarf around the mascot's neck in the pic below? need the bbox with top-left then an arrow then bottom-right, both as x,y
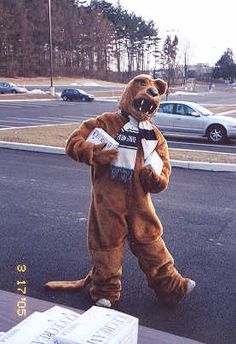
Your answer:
111,113 -> 157,183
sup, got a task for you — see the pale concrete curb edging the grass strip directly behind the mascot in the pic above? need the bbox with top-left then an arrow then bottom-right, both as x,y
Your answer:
0,141 -> 236,172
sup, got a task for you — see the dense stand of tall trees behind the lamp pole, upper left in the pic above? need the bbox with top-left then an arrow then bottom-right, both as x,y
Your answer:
0,0 -> 160,79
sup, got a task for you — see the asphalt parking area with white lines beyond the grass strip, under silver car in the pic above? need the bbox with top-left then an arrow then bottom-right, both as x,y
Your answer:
0,100 -> 236,153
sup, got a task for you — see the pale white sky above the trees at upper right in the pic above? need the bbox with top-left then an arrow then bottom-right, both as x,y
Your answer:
107,0 -> 236,65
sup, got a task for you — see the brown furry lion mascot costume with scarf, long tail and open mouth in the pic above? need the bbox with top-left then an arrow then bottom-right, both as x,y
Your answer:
46,74 -> 195,307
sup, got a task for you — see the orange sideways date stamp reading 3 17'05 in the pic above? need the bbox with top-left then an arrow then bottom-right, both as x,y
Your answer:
16,264 -> 28,317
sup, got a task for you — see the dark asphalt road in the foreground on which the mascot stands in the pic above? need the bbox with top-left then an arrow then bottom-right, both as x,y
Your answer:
0,149 -> 236,344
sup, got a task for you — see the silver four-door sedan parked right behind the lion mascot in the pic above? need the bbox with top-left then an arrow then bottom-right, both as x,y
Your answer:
153,101 -> 236,144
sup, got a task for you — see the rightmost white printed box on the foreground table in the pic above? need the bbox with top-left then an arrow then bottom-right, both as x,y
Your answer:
56,306 -> 138,344
